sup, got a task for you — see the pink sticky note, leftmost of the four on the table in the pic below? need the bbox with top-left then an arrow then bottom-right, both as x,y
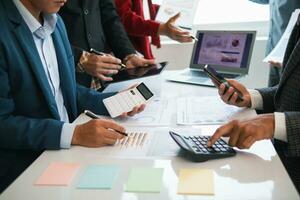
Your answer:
35,162 -> 80,186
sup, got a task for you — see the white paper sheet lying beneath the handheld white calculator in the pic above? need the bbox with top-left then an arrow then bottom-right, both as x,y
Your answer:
73,99 -> 175,127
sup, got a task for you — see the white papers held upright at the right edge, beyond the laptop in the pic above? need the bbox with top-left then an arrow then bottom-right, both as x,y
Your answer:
263,9 -> 300,63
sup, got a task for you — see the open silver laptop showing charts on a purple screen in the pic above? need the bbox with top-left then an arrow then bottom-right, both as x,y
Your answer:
167,30 -> 256,86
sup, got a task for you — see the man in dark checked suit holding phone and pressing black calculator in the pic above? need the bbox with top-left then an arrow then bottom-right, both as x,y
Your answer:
208,15 -> 300,191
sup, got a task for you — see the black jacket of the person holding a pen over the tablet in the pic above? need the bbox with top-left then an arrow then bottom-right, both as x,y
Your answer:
59,0 -> 135,87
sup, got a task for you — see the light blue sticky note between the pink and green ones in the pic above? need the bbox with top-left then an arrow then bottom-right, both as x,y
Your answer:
77,165 -> 119,189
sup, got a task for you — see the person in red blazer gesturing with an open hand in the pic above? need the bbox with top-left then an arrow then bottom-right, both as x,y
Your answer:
115,0 -> 192,59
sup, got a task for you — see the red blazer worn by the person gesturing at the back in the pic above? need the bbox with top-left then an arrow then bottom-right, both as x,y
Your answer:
115,0 -> 160,59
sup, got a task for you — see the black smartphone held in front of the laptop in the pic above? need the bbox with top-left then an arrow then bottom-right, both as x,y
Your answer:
204,65 -> 244,102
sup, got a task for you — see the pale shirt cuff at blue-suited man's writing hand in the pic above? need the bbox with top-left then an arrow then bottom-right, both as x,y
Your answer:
60,123 -> 76,149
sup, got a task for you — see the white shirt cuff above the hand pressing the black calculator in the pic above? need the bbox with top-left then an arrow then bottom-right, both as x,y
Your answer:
274,112 -> 287,142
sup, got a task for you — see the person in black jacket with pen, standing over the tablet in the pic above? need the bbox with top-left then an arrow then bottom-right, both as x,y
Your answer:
59,0 -> 154,90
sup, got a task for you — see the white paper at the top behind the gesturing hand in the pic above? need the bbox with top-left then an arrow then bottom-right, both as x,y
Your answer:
156,0 -> 199,29
